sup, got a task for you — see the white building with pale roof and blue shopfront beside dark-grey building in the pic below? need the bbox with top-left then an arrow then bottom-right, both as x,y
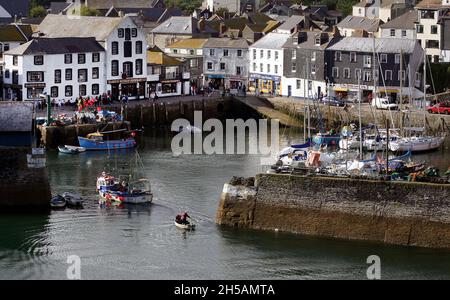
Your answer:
249,32 -> 291,95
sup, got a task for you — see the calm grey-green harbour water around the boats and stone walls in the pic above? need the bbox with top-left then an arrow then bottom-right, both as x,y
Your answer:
0,131 -> 450,279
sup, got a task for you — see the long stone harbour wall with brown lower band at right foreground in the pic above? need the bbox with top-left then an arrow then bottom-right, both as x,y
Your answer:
216,174 -> 450,249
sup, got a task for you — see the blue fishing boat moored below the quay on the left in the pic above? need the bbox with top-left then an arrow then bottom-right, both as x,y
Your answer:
78,132 -> 136,151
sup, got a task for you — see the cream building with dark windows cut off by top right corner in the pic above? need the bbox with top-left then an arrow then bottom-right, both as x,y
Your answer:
416,0 -> 450,63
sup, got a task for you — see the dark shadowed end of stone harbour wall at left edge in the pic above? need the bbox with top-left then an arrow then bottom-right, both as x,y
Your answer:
0,148 -> 51,212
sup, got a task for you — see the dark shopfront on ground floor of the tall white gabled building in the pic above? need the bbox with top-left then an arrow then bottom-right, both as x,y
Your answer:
107,78 -> 147,100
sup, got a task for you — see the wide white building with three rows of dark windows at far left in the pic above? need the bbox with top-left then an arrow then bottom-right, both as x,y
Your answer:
3,38 -> 106,102
